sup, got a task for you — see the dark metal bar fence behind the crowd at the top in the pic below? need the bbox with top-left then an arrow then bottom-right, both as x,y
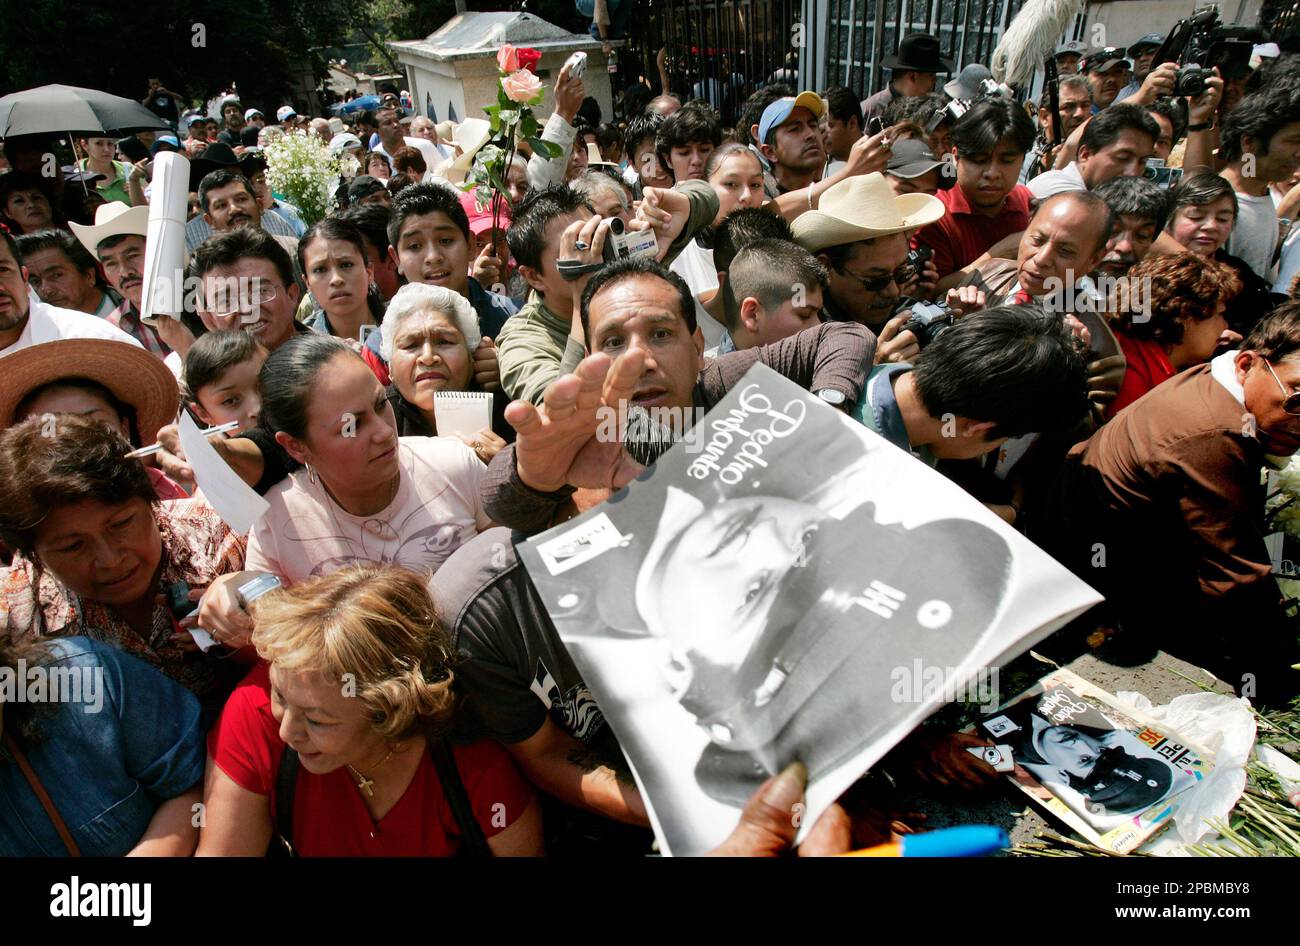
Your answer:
631,0 -> 1040,123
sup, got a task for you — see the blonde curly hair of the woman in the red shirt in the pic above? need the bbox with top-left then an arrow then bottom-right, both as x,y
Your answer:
252,565 -> 456,742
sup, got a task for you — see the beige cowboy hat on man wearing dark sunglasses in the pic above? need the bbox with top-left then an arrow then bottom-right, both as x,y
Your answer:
790,172 -> 944,252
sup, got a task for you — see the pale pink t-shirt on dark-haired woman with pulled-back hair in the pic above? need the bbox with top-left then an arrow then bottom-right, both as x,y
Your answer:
244,437 -> 491,583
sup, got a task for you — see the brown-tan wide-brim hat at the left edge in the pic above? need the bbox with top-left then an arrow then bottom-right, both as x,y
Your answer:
0,338 -> 181,447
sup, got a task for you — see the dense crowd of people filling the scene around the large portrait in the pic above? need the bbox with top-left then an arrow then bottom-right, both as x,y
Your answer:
0,14 -> 1300,856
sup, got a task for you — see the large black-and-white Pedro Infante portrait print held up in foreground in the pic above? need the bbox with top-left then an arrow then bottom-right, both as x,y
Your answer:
519,365 -> 1099,855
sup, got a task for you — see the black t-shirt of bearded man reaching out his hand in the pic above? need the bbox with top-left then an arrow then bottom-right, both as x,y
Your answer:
429,528 -> 618,758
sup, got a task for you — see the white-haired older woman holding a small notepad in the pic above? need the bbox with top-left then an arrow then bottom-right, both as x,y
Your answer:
380,282 -> 506,463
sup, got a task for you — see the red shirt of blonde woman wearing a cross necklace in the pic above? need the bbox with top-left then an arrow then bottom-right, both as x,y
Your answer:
208,663 -> 533,858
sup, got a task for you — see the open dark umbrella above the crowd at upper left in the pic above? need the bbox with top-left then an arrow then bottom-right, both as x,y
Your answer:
0,86 -> 172,138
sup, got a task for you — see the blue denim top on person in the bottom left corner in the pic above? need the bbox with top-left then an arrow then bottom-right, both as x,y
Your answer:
0,637 -> 205,858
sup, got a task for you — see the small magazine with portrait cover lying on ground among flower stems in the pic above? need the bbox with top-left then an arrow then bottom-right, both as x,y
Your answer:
976,669 -> 1214,854
